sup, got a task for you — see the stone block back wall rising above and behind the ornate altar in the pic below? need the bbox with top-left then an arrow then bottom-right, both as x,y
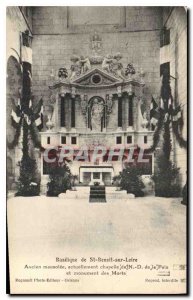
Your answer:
33,7 -> 162,109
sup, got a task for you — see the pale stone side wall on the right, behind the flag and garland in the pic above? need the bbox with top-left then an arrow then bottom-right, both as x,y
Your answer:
161,7 -> 188,185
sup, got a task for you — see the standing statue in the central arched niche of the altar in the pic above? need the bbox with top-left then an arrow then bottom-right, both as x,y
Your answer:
91,98 -> 104,132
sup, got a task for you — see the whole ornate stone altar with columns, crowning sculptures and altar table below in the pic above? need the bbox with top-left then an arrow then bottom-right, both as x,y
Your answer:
41,34 -> 152,184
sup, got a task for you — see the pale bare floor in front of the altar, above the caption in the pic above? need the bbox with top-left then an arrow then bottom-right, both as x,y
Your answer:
8,196 -> 186,292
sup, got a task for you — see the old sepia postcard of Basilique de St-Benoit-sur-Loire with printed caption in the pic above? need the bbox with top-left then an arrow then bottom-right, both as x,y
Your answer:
6,6 -> 188,294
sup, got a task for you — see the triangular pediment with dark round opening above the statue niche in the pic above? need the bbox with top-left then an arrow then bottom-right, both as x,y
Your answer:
71,68 -> 121,87
